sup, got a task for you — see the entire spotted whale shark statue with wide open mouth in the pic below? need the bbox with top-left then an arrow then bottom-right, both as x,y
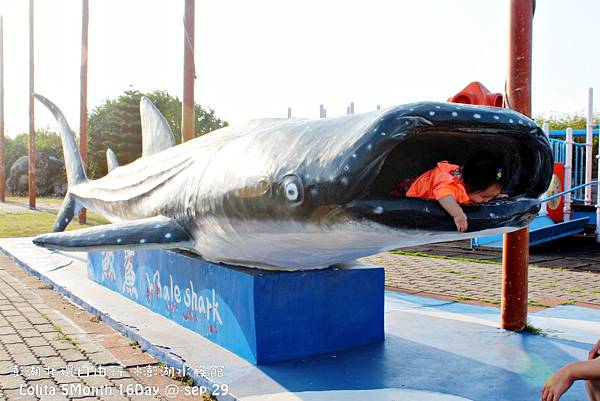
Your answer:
34,95 -> 552,270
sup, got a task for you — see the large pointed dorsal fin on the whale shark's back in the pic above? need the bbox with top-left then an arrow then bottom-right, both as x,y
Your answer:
140,96 -> 175,157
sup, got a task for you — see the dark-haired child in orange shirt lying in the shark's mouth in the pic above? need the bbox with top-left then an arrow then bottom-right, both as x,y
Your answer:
406,152 -> 504,232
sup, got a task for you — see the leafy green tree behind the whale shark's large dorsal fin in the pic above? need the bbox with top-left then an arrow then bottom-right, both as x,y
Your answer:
88,90 -> 227,178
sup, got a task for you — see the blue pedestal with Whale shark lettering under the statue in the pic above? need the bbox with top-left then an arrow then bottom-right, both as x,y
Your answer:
88,250 -> 384,364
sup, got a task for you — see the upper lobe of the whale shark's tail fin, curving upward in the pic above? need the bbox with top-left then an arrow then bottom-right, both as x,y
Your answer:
34,94 -> 88,188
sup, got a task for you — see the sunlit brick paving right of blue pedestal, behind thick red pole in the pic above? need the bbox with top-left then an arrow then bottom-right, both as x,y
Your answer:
361,253 -> 600,306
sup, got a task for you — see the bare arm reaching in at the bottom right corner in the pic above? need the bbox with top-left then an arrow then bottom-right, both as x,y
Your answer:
542,359 -> 600,401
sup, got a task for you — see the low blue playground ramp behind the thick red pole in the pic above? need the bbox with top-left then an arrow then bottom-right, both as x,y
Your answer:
471,216 -> 595,248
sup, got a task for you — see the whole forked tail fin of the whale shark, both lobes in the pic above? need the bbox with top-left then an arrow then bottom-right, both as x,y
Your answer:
34,94 -> 88,232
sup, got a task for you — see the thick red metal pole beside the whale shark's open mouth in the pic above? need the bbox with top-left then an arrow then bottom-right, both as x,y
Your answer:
500,0 -> 534,331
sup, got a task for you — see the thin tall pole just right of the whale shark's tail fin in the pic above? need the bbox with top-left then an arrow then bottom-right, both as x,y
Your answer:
79,0 -> 89,224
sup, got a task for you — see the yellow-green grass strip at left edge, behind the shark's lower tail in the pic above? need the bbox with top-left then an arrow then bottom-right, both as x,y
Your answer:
0,206 -> 108,238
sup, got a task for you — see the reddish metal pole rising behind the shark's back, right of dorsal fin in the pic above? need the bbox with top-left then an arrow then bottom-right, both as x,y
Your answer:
181,0 -> 196,142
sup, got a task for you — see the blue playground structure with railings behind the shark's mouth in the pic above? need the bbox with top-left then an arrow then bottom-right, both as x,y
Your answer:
471,88 -> 600,248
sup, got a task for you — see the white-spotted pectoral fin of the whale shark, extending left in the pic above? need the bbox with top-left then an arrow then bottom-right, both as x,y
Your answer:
33,216 -> 193,251
